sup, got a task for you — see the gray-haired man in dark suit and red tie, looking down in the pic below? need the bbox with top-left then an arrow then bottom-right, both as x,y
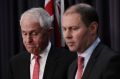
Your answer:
9,8 -> 74,79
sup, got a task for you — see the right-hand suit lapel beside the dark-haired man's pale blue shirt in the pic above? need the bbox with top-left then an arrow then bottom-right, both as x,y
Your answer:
82,43 -> 103,79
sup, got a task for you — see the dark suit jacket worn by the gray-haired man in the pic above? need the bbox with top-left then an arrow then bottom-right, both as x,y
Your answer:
9,47 -> 75,79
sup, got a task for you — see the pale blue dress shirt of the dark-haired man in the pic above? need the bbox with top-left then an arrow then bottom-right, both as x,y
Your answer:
75,37 -> 100,79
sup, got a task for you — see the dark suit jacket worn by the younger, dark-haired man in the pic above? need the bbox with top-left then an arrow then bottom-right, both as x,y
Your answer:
68,43 -> 120,79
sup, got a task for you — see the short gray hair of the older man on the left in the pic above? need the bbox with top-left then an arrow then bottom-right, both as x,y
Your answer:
20,8 -> 52,28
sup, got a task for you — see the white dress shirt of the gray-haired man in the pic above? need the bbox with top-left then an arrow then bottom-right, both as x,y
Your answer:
30,42 -> 51,79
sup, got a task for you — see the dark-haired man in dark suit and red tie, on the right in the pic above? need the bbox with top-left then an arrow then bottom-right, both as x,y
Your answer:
62,3 -> 120,79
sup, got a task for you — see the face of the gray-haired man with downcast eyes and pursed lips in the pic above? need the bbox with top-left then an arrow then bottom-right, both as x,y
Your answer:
21,17 -> 49,54
